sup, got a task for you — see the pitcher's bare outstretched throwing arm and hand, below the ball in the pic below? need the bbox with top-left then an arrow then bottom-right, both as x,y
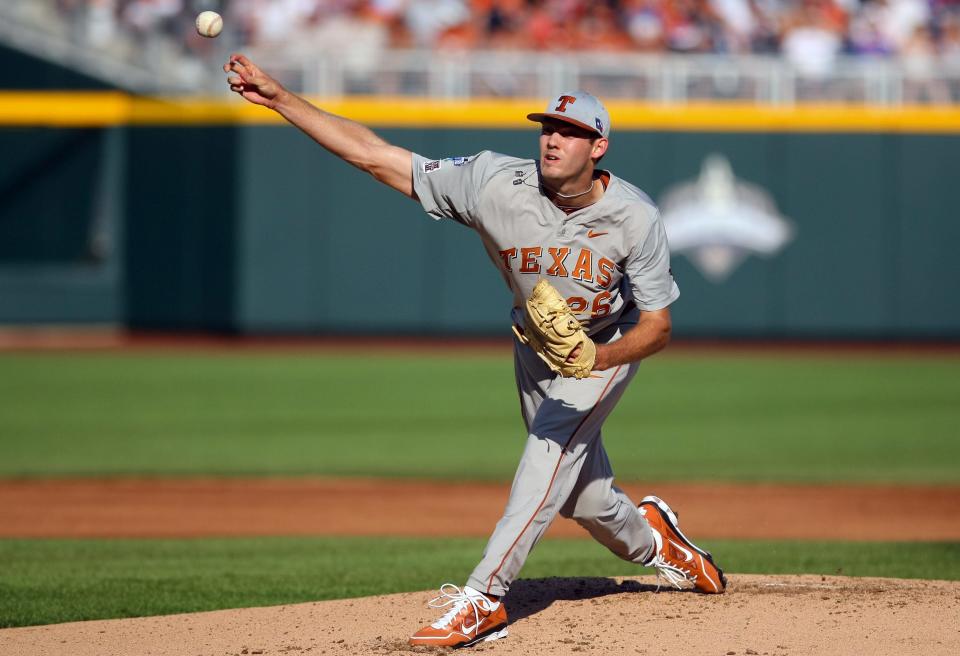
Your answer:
223,54 -> 416,198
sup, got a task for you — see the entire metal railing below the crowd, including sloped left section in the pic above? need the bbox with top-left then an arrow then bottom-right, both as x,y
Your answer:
0,0 -> 960,105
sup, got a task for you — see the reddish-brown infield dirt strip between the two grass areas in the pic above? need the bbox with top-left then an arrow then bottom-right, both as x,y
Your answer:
0,478 -> 960,541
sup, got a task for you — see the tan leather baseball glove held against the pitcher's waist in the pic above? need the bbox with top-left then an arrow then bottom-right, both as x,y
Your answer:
513,280 -> 597,378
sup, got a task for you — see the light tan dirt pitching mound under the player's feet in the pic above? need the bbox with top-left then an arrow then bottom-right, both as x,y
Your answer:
0,575 -> 960,656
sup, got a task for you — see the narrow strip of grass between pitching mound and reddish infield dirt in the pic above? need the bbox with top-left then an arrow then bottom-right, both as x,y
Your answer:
0,538 -> 960,627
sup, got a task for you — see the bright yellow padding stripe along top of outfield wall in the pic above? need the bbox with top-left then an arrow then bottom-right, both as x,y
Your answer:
0,91 -> 960,134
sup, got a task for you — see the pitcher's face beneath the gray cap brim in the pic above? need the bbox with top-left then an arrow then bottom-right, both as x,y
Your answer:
540,120 -> 607,186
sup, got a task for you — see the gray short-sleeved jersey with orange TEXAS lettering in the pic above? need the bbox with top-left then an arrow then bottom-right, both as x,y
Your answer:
413,151 -> 680,336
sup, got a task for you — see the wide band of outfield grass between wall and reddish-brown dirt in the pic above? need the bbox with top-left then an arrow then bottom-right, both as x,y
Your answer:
0,352 -> 960,483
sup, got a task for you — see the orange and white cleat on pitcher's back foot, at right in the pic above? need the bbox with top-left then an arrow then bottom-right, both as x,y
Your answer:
637,496 -> 727,594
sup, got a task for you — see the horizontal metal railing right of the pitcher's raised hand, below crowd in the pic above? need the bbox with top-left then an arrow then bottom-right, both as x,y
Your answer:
252,51 -> 960,105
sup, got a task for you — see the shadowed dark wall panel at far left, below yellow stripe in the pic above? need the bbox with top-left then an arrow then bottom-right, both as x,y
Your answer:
0,127 -> 128,324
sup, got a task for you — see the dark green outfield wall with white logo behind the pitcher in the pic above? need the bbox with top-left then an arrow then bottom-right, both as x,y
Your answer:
0,98 -> 960,339
